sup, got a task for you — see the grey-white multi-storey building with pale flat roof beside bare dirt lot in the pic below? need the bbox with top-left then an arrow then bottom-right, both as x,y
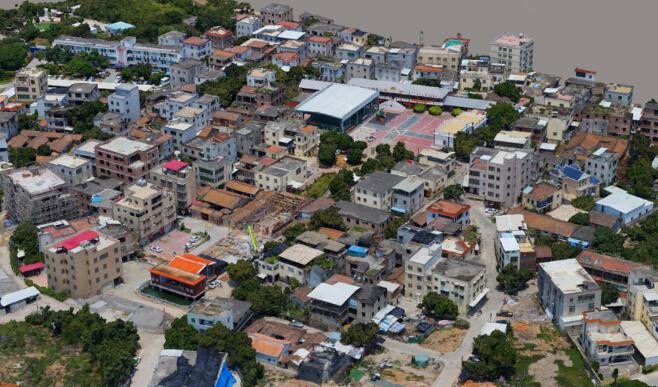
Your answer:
538,259 -> 601,330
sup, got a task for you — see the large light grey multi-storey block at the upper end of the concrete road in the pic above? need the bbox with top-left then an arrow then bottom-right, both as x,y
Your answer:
467,147 -> 536,208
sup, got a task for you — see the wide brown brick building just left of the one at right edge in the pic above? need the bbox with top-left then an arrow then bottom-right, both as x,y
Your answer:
574,104 -> 633,136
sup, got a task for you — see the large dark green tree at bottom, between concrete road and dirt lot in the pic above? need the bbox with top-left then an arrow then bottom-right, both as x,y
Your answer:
463,331 -> 517,381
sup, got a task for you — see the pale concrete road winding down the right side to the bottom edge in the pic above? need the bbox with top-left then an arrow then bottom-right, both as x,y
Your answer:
433,201 -> 505,387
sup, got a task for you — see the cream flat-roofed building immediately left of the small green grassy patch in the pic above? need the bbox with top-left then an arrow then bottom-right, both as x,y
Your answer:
256,156 -> 309,192
